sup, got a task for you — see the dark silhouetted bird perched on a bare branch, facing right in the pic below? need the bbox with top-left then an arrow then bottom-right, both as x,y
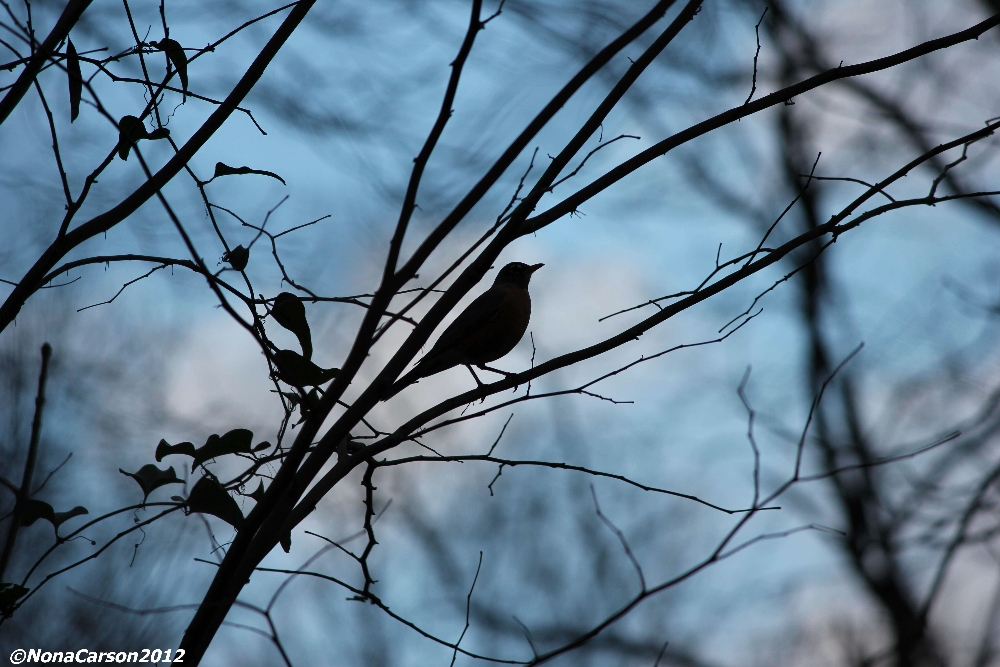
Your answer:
382,262 -> 544,400
